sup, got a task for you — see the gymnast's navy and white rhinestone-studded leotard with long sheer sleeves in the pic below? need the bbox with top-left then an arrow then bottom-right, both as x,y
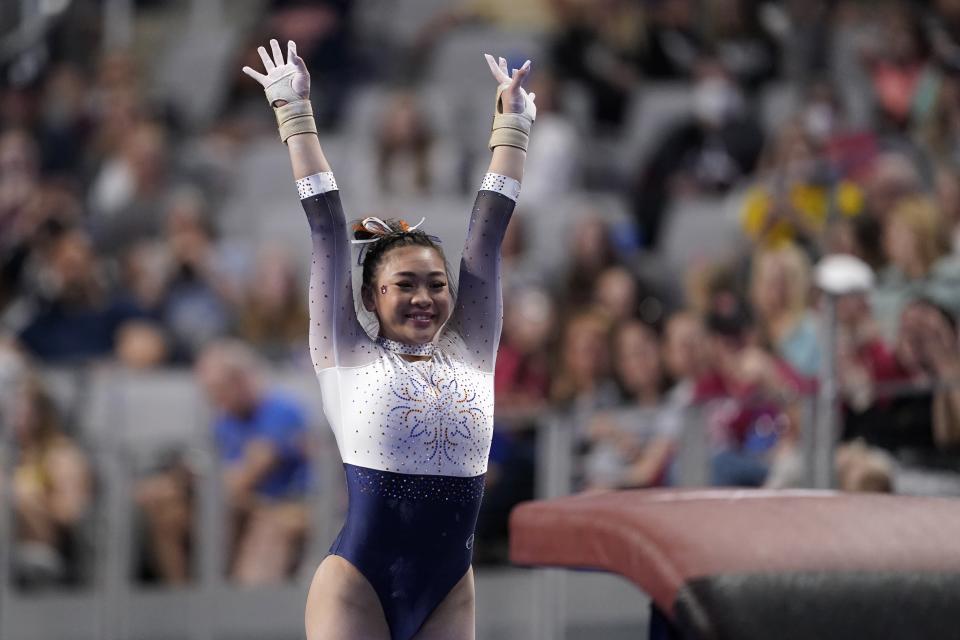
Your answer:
297,173 -> 520,640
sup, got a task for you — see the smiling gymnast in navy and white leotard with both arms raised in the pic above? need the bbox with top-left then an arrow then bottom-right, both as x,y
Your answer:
243,40 -> 536,640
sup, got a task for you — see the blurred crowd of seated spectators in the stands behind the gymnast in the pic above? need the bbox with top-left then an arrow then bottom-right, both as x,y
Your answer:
0,0 -> 960,584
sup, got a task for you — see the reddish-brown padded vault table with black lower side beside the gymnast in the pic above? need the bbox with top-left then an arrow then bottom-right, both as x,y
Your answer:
510,489 -> 960,640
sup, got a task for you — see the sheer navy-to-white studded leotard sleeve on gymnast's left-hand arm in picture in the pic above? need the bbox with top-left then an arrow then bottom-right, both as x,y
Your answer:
297,172 -> 375,372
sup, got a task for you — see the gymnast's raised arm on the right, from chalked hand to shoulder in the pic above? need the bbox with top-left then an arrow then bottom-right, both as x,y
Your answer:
450,55 -> 537,372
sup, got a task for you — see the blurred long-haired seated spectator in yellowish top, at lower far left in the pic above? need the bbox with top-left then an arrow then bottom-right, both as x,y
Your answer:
7,377 -> 93,587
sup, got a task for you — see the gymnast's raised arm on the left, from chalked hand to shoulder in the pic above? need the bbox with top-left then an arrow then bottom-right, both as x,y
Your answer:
243,40 -> 373,371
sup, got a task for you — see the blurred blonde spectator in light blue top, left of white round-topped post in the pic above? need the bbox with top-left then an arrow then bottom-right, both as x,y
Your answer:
750,245 -> 820,378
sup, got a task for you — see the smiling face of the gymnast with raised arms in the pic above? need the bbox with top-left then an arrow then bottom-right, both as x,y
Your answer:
362,245 -> 453,344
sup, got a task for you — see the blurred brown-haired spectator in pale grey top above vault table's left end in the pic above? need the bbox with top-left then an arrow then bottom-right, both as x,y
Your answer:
584,320 -> 681,489
